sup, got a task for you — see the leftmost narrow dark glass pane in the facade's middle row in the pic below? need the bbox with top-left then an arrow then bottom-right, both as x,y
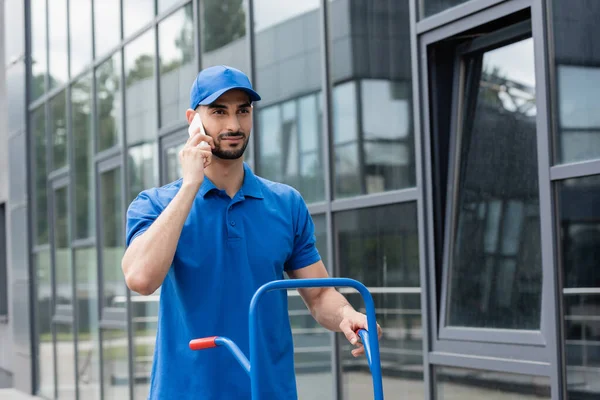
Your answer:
31,104 -> 48,244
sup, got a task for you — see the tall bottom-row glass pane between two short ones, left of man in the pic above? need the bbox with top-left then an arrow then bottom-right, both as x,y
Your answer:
73,247 -> 100,400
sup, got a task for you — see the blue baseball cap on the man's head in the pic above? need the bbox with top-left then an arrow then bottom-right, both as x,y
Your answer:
190,65 -> 260,110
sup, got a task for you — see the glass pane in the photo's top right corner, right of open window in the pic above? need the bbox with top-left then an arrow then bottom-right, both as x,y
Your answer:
552,0 -> 600,163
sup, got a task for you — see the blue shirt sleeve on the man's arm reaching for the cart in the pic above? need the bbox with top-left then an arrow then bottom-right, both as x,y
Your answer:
285,193 -> 321,271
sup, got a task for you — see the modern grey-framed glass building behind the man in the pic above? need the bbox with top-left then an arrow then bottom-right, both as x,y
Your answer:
0,0 -> 600,400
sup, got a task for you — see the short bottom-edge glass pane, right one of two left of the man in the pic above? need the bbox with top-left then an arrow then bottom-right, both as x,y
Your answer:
102,329 -> 129,399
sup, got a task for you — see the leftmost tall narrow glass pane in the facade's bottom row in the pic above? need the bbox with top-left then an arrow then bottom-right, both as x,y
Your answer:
33,250 -> 54,399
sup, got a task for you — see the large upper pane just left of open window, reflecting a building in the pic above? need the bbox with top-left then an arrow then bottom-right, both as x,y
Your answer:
329,1 -> 416,198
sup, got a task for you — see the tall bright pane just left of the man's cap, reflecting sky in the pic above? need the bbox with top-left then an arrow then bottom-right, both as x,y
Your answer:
158,3 -> 198,126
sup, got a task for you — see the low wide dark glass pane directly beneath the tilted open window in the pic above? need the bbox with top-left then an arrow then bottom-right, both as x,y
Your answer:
435,367 -> 551,400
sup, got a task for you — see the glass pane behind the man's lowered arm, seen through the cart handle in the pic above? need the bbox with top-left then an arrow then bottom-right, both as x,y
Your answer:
288,215 -> 335,400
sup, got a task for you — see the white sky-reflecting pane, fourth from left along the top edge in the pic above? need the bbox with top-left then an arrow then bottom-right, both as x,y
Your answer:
94,0 -> 120,59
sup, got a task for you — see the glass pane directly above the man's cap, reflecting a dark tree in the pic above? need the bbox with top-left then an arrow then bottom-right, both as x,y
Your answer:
202,0 -> 250,73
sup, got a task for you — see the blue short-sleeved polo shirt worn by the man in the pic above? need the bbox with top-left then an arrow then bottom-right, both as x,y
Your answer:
126,164 -> 320,400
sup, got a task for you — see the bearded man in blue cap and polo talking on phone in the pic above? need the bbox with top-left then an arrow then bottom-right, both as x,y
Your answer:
122,66 -> 380,400
